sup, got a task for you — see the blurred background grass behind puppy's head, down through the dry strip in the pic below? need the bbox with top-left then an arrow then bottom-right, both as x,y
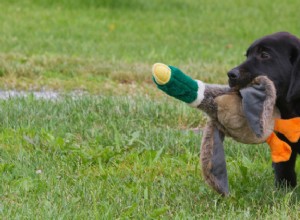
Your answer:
0,0 -> 300,92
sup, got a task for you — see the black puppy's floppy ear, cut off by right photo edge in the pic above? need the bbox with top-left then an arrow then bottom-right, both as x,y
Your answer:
286,49 -> 300,102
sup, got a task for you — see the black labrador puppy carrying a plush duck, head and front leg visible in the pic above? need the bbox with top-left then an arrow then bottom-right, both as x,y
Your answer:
228,32 -> 300,187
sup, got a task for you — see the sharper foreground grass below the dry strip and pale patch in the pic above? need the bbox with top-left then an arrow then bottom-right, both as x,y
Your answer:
0,96 -> 299,219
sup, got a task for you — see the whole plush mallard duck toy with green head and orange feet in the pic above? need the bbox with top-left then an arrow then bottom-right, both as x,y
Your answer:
152,63 -> 300,195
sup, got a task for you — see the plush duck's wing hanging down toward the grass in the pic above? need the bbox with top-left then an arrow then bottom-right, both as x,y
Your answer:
200,121 -> 229,196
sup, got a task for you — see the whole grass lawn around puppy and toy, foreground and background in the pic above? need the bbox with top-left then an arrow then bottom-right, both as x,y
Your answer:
0,0 -> 300,219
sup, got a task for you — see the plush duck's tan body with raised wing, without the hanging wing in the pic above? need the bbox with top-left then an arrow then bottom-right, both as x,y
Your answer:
197,76 -> 280,144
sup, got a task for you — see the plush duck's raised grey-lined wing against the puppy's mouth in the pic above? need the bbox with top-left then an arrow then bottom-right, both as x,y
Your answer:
240,76 -> 276,137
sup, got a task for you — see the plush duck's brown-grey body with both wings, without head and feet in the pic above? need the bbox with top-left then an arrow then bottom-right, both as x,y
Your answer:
192,76 -> 280,195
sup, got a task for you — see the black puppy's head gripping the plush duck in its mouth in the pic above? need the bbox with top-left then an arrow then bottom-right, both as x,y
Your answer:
228,32 -> 300,101
